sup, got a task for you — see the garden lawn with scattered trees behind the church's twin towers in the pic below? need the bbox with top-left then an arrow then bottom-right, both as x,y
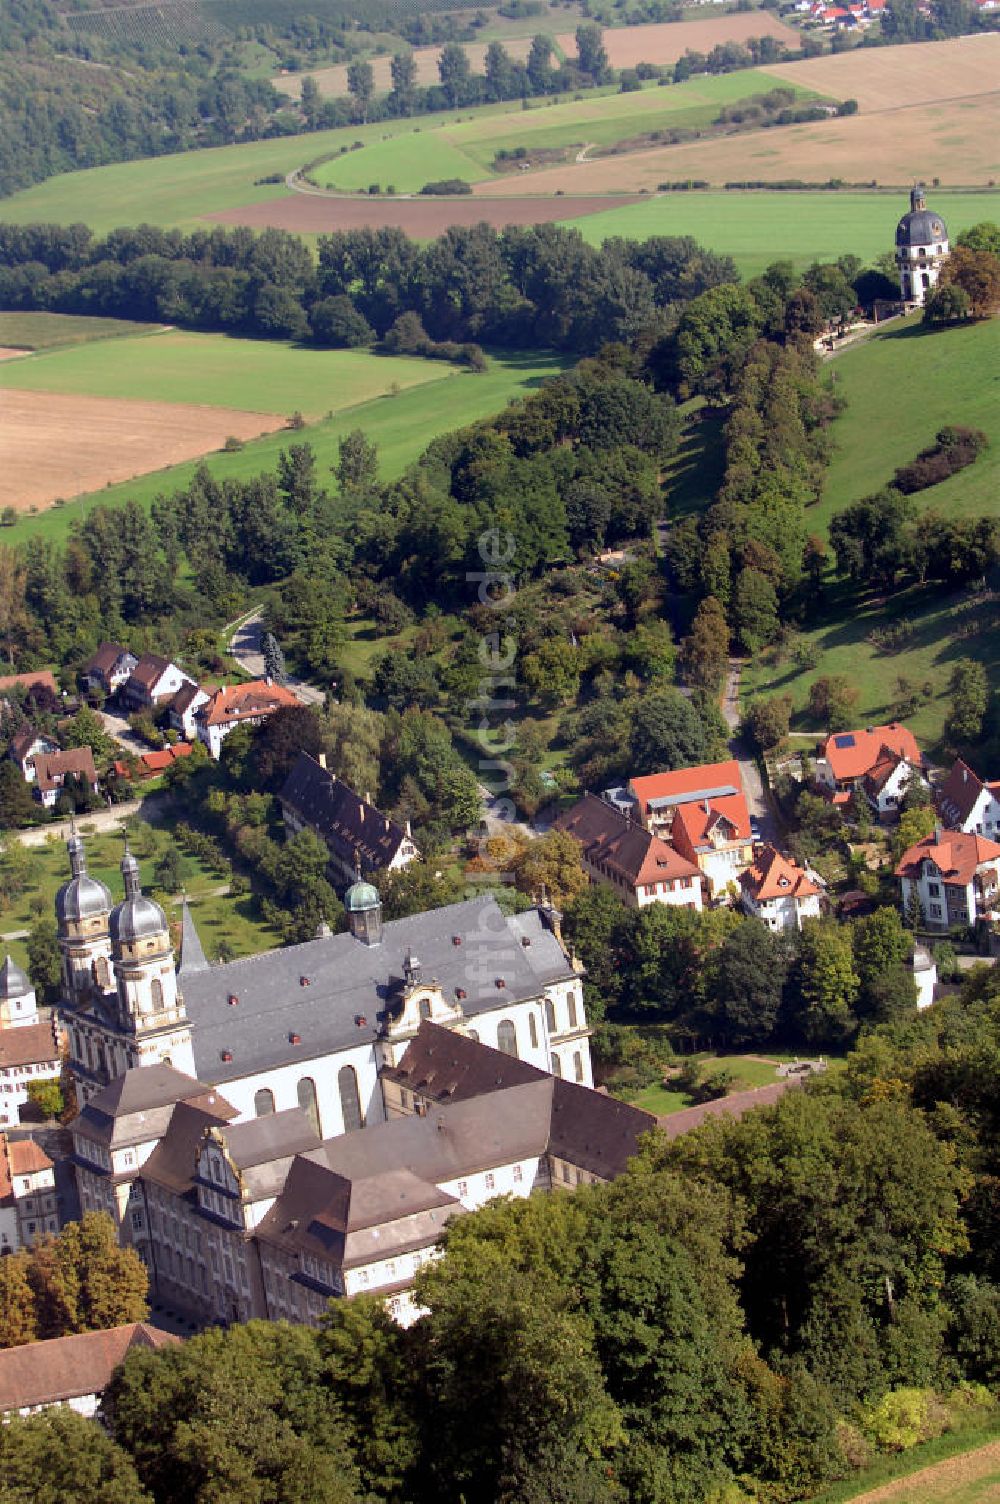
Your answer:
0,817 -> 280,966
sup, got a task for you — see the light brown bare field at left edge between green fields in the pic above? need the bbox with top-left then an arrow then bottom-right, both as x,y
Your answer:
0,388 -> 286,511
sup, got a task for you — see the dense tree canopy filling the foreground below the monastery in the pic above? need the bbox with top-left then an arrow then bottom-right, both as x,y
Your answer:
0,967 -> 1000,1504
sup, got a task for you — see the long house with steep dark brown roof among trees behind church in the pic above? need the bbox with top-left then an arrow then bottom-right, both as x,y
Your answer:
278,752 -> 420,881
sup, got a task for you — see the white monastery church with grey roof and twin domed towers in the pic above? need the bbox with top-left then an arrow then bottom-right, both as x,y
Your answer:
56,833 -> 592,1139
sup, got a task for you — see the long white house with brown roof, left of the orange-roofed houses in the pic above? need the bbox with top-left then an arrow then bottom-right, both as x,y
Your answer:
553,794 -> 702,911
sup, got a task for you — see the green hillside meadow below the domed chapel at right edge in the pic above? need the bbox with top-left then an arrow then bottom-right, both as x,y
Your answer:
809,314 -> 1000,531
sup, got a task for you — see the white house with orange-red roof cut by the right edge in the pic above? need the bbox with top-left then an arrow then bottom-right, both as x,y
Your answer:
896,830 -> 1000,931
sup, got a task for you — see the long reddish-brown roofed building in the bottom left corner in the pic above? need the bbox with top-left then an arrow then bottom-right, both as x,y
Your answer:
0,1321 -> 180,1418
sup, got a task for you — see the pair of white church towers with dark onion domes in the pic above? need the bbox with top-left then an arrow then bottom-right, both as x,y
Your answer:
56,832 -> 195,1107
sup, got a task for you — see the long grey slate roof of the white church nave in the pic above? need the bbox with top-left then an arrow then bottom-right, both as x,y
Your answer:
183,898 -> 576,1084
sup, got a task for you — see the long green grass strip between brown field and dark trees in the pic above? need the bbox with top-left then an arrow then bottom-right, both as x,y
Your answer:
3,350 -> 565,541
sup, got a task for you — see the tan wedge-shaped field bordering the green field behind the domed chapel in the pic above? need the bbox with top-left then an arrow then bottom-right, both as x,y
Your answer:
474,90 -> 1000,192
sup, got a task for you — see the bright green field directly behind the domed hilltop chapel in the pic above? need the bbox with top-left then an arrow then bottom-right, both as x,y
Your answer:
574,191 -> 1000,279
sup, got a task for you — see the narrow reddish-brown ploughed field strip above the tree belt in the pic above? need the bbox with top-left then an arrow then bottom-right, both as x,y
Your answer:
205,191 -> 636,241
